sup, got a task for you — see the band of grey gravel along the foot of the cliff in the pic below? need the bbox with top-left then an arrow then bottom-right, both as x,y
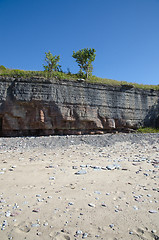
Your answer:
0,133 -> 159,153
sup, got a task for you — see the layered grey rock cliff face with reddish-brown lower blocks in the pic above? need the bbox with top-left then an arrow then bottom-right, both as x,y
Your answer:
0,77 -> 159,136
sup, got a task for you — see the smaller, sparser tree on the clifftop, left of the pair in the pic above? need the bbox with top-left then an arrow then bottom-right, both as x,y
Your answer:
43,51 -> 61,72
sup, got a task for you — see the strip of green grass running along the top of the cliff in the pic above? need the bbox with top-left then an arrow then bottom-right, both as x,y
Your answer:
0,65 -> 159,90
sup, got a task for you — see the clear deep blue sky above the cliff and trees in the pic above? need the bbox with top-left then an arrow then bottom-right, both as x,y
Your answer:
0,0 -> 159,84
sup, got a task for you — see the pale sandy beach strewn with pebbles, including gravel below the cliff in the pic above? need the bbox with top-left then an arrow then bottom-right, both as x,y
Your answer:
0,134 -> 159,240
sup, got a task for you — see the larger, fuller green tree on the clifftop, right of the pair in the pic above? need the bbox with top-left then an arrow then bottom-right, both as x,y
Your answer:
72,48 -> 96,78
